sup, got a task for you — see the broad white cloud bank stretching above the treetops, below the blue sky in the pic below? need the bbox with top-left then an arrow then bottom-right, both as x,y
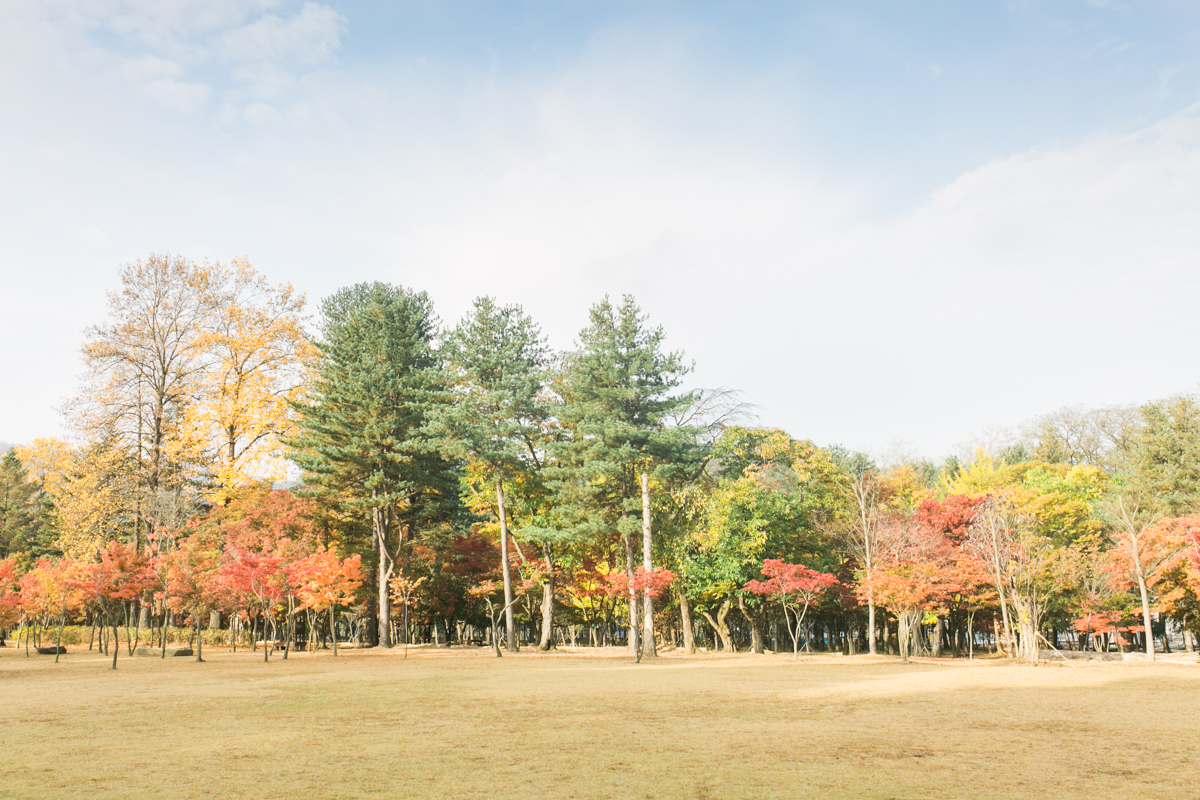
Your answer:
0,10 -> 1200,455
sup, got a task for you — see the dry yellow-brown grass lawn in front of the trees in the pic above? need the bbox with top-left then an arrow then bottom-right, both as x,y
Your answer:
0,644 -> 1200,800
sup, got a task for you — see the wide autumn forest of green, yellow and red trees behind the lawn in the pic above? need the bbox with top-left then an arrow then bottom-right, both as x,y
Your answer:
0,254 -> 1200,668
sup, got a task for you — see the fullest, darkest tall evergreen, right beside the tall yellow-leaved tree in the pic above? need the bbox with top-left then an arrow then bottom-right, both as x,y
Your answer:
288,283 -> 457,648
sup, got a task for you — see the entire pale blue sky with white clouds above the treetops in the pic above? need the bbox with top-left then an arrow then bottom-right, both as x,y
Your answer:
0,0 -> 1200,458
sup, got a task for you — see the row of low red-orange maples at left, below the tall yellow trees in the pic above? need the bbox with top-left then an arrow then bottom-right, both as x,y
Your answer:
0,489 -> 362,668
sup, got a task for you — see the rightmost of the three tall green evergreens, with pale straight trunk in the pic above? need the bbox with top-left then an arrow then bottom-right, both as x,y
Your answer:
551,295 -> 697,656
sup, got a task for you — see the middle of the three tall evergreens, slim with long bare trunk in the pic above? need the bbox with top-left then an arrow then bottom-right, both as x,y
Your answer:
436,297 -> 550,652
